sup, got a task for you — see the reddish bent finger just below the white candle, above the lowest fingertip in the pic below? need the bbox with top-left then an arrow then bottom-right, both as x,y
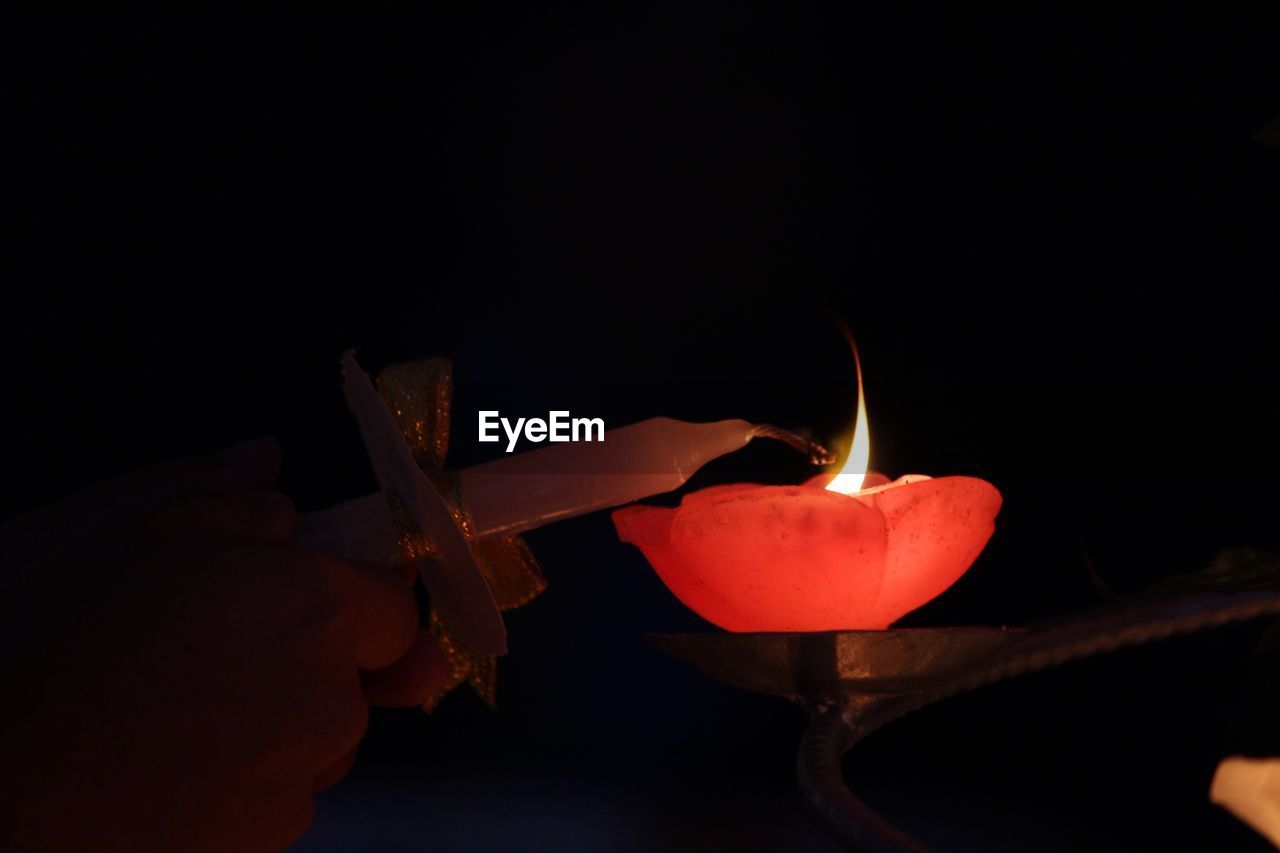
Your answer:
339,562 -> 419,670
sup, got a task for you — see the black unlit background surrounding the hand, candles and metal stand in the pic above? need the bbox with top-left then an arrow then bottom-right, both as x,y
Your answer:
10,3 -> 1280,850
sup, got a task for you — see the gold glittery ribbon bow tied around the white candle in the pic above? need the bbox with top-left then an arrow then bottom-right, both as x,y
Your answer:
378,359 -> 547,711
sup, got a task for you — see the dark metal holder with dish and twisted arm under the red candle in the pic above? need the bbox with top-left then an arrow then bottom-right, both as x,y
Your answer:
649,590 -> 1280,853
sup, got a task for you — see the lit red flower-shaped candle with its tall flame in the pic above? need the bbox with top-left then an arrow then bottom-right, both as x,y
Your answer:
613,348 -> 1001,631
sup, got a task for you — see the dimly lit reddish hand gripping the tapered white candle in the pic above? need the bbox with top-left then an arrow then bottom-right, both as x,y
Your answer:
0,441 -> 444,850
